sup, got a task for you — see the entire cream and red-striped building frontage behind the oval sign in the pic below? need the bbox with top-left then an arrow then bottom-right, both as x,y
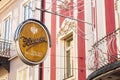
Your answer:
0,0 -> 120,80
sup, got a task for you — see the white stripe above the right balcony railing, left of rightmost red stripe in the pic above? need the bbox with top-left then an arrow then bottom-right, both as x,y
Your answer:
96,0 -> 106,40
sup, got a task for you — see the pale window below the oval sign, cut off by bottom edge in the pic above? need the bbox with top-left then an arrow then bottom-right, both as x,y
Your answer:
17,67 -> 29,80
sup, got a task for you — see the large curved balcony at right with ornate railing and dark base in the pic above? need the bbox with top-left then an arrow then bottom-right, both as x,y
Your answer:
87,28 -> 120,80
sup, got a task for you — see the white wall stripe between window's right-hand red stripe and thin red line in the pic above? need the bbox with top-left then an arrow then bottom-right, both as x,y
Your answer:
84,0 -> 93,77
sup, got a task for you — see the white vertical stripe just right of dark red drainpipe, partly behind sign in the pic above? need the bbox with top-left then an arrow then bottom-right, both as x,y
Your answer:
43,0 -> 52,80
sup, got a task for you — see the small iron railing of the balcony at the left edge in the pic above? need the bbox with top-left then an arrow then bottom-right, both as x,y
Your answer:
0,40 -> 11,58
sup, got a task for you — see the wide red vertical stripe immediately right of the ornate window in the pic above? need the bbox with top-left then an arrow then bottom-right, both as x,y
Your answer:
77,0 -> 86,80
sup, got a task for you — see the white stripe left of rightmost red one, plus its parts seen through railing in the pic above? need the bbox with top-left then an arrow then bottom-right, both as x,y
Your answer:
96,0 -> 108,66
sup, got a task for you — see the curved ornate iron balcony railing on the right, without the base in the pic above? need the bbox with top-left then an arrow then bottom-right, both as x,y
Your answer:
87,28 -> 120,71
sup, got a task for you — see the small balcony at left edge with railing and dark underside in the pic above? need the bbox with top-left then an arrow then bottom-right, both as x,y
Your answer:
0,40 -> 10,71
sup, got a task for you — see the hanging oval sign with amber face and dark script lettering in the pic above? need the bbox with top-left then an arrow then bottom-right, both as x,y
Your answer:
14,19 -> 51,65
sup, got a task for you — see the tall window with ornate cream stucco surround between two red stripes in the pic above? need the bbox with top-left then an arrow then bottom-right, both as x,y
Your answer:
57,19 -> 78,80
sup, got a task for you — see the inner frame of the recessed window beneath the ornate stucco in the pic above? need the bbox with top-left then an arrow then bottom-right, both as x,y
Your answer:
64,35 -> 74,79
